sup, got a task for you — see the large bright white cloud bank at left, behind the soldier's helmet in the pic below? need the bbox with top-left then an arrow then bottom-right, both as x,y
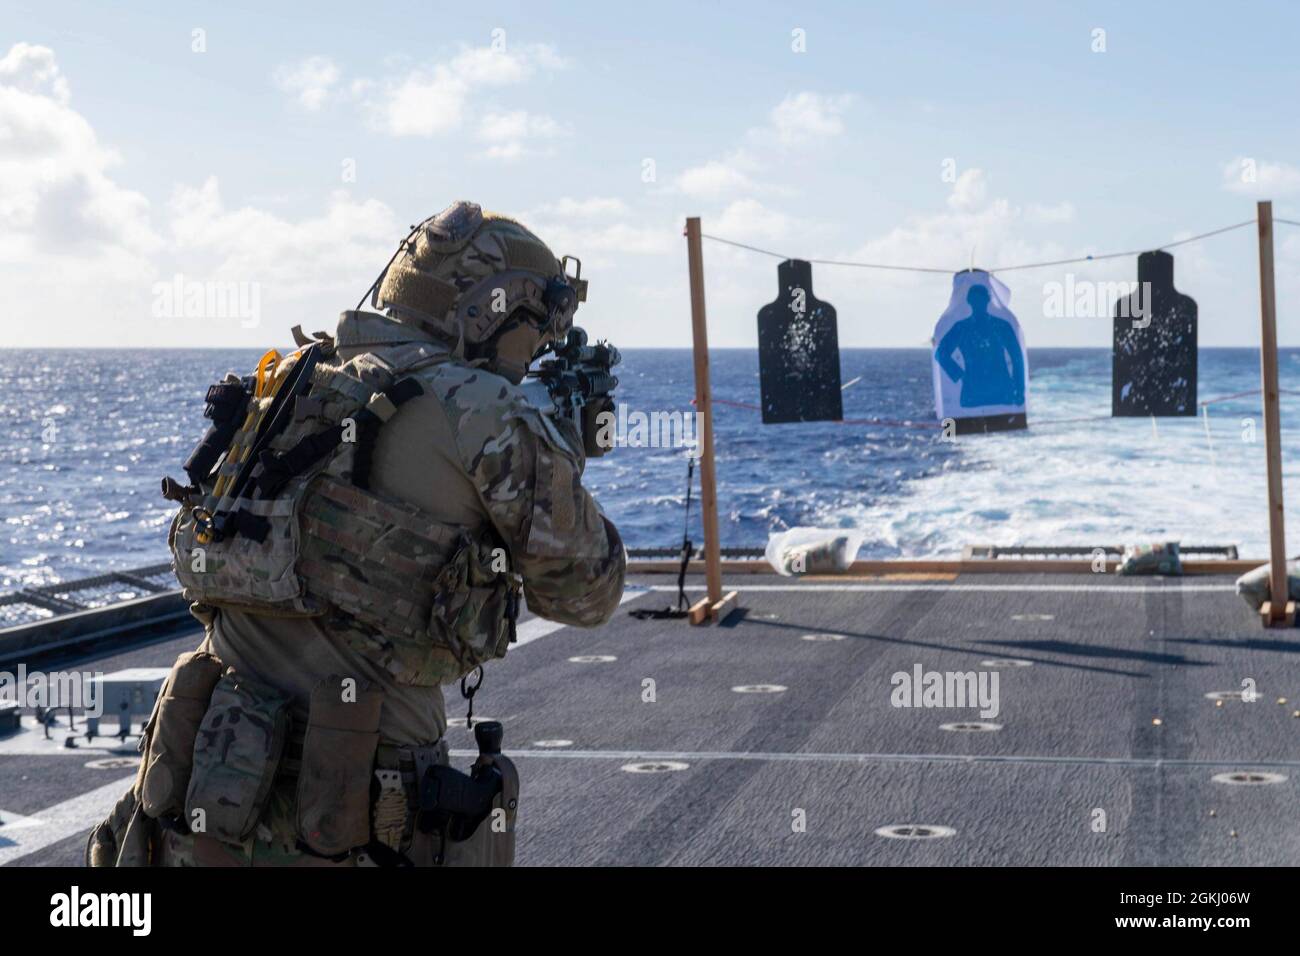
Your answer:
0,44 -> 404,346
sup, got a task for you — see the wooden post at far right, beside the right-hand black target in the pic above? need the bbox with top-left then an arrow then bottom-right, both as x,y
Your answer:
1257,202 -> 1295,627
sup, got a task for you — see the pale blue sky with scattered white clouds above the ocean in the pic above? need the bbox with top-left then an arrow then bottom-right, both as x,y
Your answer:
0,0 -> 1300,347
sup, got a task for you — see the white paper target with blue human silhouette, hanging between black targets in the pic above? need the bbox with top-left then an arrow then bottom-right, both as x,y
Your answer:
933,269 -> 1028,434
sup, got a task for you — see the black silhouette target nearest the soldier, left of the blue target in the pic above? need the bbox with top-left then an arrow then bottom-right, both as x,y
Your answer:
758,259 -> 844,425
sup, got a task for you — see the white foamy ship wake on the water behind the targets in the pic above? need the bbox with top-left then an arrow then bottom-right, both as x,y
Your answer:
826,369 -> 1300,558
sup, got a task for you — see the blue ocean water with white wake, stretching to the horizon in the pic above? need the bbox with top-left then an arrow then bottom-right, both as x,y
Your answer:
0,349 -> 1300,589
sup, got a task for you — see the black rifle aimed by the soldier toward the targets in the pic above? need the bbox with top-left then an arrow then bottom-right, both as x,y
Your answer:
523,325 -> 623,458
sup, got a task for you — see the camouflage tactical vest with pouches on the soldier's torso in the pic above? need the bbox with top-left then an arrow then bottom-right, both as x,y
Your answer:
164,341 -> 519,684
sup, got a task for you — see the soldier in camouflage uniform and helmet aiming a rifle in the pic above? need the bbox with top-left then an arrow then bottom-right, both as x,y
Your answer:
88,203 -> 625,865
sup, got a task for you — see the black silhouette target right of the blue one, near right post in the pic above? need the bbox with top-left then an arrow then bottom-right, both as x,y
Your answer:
1110,251 -> 1196,418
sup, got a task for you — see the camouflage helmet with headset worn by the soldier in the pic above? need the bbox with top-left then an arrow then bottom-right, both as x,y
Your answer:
377,200 -> 586,347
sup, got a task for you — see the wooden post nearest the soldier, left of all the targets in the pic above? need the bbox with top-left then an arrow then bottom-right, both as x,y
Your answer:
686,216 -> 736,624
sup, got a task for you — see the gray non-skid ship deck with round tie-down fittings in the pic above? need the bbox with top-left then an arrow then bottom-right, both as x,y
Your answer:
0,575 -> 1300,865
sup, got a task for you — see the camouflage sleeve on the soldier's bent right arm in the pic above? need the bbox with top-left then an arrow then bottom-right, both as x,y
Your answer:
449,376 -> 627,627
